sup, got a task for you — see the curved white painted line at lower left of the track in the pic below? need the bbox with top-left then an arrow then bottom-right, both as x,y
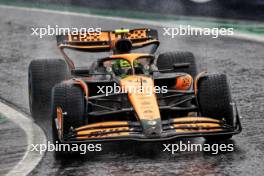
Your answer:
0,102 -> 47,176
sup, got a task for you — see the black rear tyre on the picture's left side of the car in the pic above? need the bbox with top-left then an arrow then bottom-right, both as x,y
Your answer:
28,59 -> 69,117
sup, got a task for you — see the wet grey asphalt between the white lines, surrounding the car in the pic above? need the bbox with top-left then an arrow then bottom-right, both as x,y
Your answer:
0,5 -> 264,176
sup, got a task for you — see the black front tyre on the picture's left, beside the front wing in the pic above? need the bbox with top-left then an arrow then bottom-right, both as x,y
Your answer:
51,83 -> 85,143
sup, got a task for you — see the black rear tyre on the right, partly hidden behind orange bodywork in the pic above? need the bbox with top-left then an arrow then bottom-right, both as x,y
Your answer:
157,52 -> 197,78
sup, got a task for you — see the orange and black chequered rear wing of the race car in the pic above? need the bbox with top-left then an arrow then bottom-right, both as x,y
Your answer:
56,28 -> 159,52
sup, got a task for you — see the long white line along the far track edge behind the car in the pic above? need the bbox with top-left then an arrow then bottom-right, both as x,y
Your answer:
0,5 -> 264,43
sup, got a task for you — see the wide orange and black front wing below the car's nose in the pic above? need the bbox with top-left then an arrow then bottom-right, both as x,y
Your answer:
57,108 -> 242,143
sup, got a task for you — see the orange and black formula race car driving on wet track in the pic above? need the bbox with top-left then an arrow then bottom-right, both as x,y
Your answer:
29,28 -> 241,148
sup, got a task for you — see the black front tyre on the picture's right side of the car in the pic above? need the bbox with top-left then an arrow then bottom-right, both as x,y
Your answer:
197,74 -> 235,141
